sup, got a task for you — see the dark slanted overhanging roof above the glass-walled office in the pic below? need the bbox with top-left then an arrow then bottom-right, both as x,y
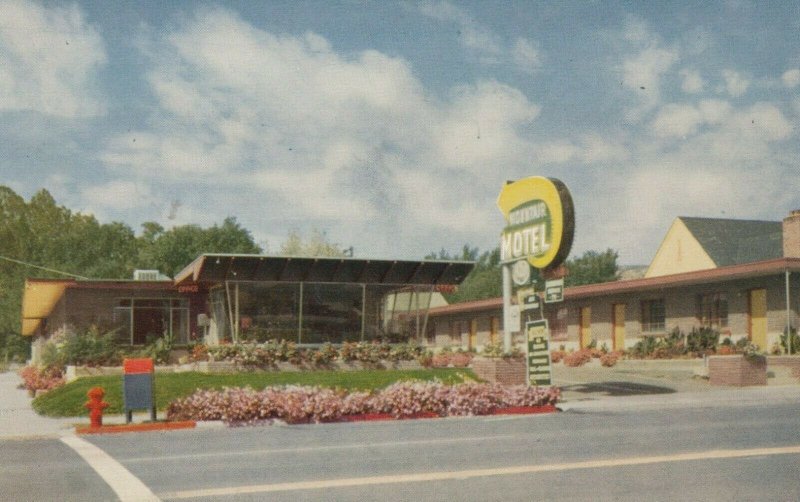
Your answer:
175,254 -> 475,285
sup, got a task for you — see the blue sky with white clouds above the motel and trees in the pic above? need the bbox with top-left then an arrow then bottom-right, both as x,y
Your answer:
0,0 -> 800,265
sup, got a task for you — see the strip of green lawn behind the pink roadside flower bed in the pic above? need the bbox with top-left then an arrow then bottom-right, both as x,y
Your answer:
33,368 -> 476,417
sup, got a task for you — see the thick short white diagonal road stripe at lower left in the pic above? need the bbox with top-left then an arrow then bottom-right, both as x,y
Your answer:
61,436 -> 161,502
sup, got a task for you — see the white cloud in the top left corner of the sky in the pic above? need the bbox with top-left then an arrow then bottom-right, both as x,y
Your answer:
0,0 -> 106,118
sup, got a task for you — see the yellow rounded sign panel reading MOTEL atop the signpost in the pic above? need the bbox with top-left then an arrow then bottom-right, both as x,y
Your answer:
497,176 -> 575,269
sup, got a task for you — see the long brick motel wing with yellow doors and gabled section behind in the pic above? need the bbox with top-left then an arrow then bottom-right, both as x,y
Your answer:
425,211 -> 800,351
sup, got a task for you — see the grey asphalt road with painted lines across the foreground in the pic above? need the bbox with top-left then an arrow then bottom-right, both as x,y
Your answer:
0,389 -> 800,501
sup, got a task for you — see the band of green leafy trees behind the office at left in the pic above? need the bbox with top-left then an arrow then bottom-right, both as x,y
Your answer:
0,186 -> 261,338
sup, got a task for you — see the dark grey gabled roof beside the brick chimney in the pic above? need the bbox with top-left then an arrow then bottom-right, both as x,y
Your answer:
679,216 -> 783,267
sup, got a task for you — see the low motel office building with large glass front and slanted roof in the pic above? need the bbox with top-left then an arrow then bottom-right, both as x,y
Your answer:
22,254 -> 474,362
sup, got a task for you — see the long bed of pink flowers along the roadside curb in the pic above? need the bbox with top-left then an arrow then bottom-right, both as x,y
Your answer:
167,382 -> 560,424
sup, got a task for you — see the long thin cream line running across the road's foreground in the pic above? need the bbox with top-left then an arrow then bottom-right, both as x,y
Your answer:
161,446 -> 800,499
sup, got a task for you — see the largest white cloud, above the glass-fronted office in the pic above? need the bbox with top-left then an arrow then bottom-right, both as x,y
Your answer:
97,10 -> 539,253
